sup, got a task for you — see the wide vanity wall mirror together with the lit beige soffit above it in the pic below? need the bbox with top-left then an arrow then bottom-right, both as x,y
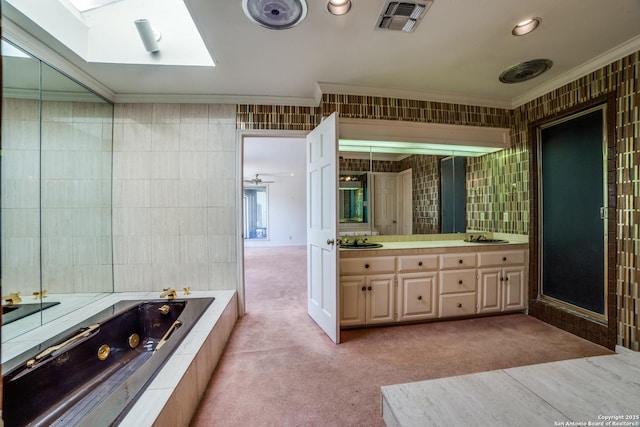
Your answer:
338,119 -> 509,235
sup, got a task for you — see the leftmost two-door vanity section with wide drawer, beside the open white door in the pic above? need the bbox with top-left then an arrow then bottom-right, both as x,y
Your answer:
340,257 -> 395,326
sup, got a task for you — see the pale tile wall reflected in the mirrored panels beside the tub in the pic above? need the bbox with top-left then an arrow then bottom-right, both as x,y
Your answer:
2,98 -> 113,295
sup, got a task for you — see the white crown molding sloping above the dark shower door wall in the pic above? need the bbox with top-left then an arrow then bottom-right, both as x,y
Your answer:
511,35 -> 640,108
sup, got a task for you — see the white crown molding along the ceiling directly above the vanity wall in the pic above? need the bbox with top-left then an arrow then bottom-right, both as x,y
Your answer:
318,82 -> 511,109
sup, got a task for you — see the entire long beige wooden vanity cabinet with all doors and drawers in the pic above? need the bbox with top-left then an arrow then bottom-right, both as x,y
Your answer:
340,245 -> 528,327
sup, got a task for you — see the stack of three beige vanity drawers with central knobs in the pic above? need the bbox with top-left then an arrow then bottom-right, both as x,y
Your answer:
439,253 -> 477,317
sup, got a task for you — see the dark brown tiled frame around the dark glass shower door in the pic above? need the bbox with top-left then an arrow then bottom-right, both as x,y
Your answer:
527,92 -> 618,349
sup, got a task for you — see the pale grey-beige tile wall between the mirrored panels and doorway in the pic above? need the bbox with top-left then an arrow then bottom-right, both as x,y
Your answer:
113,104 -> 239,292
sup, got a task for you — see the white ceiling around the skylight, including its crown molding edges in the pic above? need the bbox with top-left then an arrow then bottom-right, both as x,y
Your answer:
2,0 -> 640,108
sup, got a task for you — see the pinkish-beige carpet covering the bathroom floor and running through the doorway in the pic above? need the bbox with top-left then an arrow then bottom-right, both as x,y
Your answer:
192,247 -> 611,427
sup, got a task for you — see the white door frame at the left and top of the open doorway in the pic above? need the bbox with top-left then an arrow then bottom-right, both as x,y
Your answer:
235,129 -> 309,317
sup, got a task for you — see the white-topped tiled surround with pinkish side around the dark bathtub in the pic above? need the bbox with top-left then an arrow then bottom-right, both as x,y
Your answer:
2,291 -> 238,427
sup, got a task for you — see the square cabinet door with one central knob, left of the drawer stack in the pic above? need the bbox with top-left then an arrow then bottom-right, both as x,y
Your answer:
398,271 -> 438,321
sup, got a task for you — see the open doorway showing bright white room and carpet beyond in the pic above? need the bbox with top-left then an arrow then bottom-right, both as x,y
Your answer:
240,136 -> 306,313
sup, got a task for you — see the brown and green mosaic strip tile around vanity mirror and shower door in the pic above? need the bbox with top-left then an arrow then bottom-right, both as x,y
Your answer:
237,52 -> 640,351
